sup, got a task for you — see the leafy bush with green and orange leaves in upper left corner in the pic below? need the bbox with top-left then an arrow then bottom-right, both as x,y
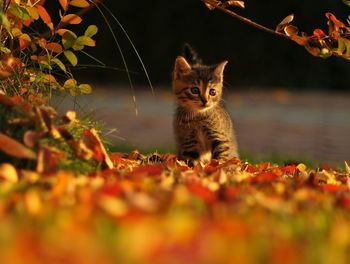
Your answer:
0,0 -> 98,102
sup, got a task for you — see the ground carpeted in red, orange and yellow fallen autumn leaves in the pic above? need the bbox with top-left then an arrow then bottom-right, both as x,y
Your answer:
0,95 -> 350,264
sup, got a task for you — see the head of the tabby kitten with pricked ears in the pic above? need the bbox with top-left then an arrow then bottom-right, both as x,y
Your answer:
173,56 -> 227,112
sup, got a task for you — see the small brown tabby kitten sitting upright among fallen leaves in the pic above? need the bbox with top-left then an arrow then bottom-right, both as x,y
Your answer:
173,44 -> 239,165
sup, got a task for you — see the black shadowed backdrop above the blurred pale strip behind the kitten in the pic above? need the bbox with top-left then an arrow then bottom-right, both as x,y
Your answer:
72,0 -> 350,90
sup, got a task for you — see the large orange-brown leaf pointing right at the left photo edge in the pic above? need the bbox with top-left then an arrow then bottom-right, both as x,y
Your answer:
0,133 -> 36,159
